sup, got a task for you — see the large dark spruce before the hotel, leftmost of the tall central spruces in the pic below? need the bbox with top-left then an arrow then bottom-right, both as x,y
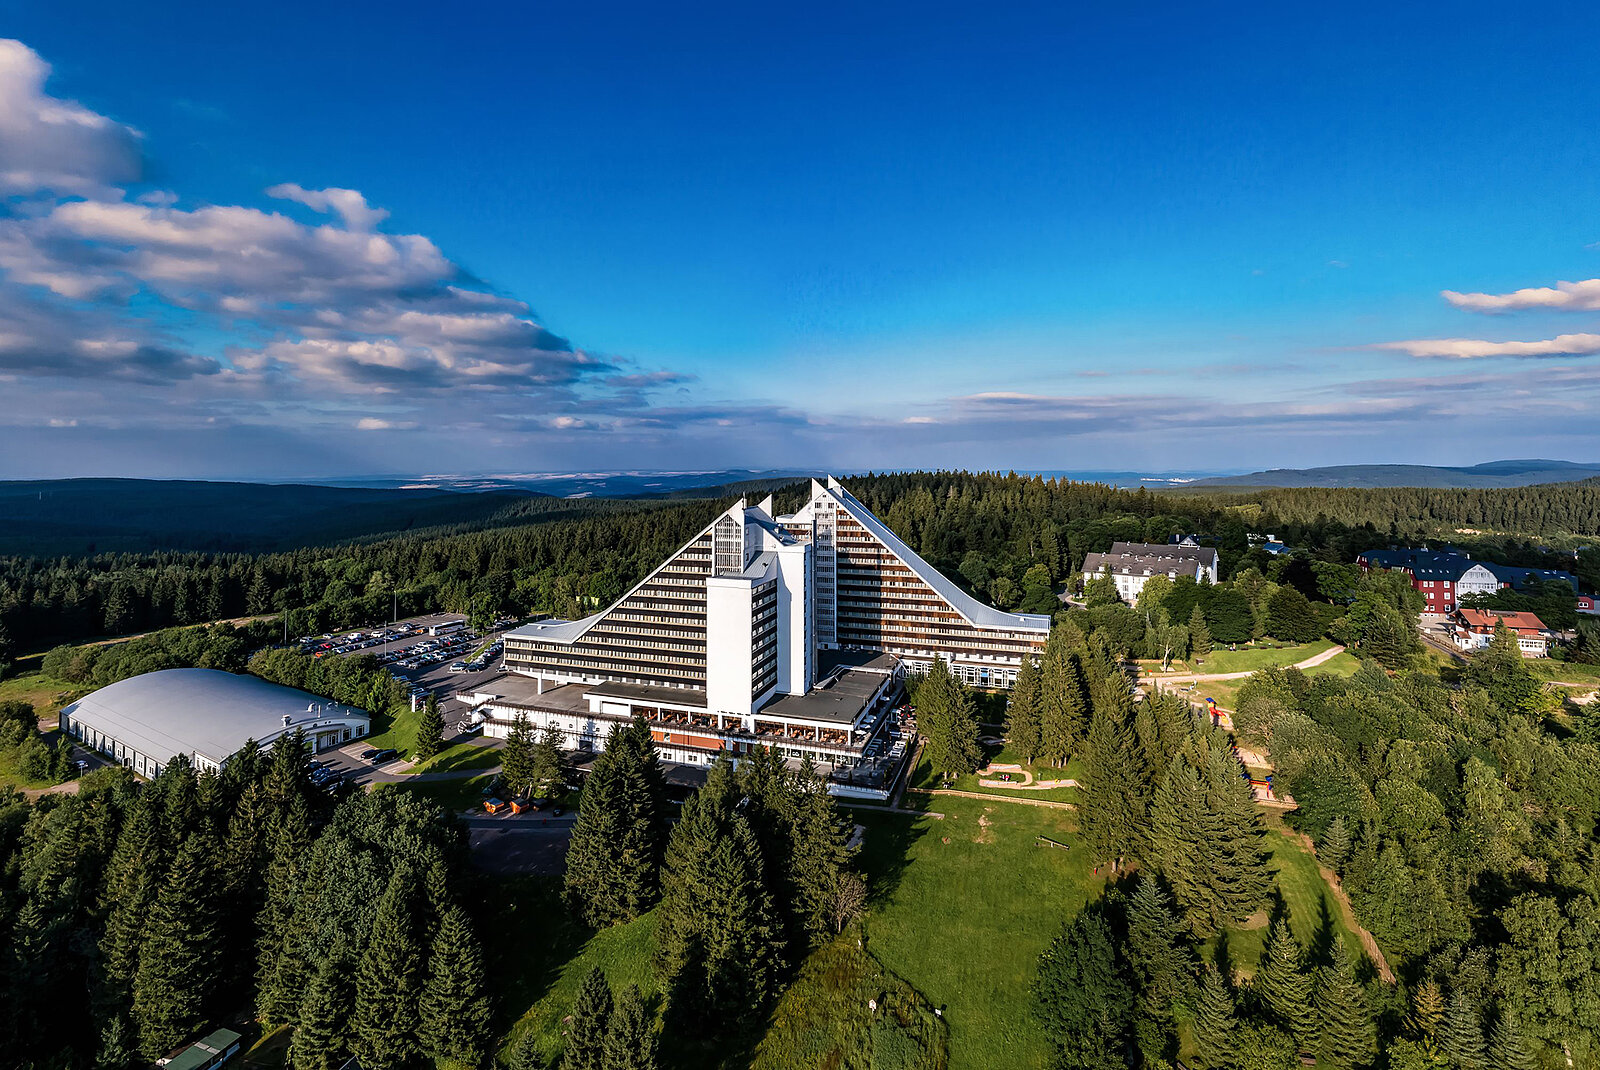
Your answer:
565,718 -> 666,926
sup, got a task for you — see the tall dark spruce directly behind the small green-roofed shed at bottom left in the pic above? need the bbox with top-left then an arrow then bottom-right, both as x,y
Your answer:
133,832 -> 221,1059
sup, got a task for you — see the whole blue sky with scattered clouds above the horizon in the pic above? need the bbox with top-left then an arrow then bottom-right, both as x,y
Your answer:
0,2 -> 1600,478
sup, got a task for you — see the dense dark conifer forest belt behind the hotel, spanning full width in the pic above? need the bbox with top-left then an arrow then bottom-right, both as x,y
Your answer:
0,472 -> 1600,662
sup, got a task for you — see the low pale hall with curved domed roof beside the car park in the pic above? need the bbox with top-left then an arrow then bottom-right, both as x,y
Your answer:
61,669 -> 371,777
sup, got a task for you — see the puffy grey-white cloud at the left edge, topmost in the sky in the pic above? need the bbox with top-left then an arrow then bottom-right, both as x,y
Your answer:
0,40 -> 141,197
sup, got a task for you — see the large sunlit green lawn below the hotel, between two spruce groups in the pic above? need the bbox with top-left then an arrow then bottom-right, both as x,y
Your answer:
853,795 -> 1101,1070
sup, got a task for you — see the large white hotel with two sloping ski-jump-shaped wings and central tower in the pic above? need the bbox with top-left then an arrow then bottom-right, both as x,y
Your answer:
462,478 -> 1050,780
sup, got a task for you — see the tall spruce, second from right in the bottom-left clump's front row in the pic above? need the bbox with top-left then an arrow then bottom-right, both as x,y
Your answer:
350,867 -> 424,1067
